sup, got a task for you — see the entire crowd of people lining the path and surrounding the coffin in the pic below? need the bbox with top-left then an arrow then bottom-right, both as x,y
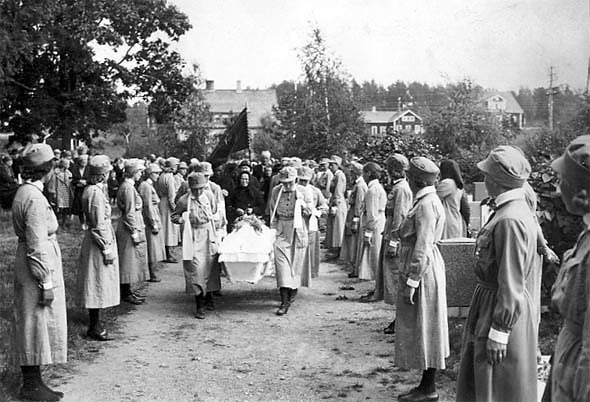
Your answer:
0,136 -> 590,402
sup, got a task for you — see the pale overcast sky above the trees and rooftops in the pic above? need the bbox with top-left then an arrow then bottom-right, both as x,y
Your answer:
170,0 -> 590,90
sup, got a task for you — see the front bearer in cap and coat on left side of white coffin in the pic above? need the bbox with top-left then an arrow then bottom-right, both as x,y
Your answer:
171,173 -> 219,319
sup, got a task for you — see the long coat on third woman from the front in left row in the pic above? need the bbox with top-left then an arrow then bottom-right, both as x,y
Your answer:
116,179 -> 149,284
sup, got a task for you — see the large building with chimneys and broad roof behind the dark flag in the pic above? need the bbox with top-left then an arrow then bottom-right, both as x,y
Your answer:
203,80 -> 277,140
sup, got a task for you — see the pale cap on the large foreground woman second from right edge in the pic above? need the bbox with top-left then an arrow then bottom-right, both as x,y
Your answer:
477,145 -> 531,188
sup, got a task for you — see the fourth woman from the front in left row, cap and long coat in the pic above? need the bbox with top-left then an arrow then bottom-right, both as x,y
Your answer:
138,163 -> 166,282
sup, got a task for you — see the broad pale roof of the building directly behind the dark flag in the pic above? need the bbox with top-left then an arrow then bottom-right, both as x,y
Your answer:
203,89 -> 277,127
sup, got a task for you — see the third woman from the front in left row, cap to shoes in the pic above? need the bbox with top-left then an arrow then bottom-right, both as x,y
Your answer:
116,159 -> 148,304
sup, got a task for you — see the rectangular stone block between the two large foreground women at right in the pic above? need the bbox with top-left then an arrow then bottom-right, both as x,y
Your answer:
438,237 -> 477,316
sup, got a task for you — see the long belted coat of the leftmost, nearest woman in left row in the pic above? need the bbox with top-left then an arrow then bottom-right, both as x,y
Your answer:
12,182 -> 68,366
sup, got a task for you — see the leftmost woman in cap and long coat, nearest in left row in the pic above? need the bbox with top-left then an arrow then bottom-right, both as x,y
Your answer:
12,144 -> 67,401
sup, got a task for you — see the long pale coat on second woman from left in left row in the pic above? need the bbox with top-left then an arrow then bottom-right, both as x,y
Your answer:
78,184 -> 120,308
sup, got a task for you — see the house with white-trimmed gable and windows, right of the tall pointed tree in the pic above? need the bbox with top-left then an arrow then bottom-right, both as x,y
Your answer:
361,107 -> 424,136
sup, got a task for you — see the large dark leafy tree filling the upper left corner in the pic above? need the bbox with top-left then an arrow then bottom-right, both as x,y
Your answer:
0,0 -> 192,146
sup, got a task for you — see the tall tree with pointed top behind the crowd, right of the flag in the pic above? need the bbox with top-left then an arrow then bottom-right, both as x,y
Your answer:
275,28 -> 365,158
